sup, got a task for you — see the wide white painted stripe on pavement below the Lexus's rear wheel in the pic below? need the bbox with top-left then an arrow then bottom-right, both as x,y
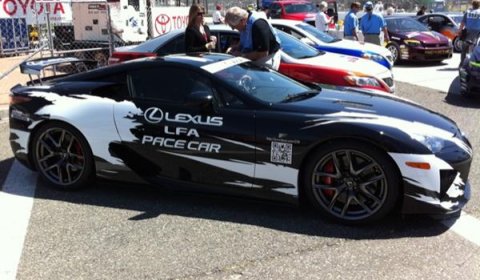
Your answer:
0,161 -> 37,280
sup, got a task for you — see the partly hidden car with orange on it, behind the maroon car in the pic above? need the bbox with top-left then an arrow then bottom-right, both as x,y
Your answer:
417,14 -> 463,52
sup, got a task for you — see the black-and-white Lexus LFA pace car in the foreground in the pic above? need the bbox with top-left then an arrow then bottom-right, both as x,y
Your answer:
10,54 -> 473,224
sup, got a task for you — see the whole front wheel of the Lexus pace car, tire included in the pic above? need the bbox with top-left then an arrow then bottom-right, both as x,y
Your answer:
302,141 -> 401,224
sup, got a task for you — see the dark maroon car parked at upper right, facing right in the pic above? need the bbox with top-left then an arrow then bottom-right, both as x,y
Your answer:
385,16 -> 453,63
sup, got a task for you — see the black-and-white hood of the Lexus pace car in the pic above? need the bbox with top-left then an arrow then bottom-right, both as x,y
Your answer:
278,89 -> 461,138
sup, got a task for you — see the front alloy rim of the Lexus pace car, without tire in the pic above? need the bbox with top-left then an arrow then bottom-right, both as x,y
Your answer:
311,149 -> 388,221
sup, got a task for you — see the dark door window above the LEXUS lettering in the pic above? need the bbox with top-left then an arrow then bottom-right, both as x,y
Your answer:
128,66 -> 213,104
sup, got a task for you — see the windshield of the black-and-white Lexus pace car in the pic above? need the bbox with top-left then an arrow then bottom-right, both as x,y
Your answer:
213,62 -> 311,103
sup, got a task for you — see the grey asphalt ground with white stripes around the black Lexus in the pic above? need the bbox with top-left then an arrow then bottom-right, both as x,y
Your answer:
0,53 -> 480,279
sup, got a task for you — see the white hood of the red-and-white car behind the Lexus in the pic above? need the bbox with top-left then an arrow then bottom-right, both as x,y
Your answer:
282,52 -> 392,78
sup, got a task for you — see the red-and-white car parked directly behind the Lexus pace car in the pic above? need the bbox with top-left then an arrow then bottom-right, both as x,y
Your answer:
110,25 -> 395,93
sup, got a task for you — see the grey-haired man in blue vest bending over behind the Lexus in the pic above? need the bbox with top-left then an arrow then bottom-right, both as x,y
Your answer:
225,7 -> 280,70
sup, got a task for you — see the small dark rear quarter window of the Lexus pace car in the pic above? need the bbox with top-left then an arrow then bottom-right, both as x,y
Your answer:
92,73 -> 130,101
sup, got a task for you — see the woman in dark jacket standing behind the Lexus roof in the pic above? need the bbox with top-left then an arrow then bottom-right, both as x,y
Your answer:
185,4 -> 217,53
